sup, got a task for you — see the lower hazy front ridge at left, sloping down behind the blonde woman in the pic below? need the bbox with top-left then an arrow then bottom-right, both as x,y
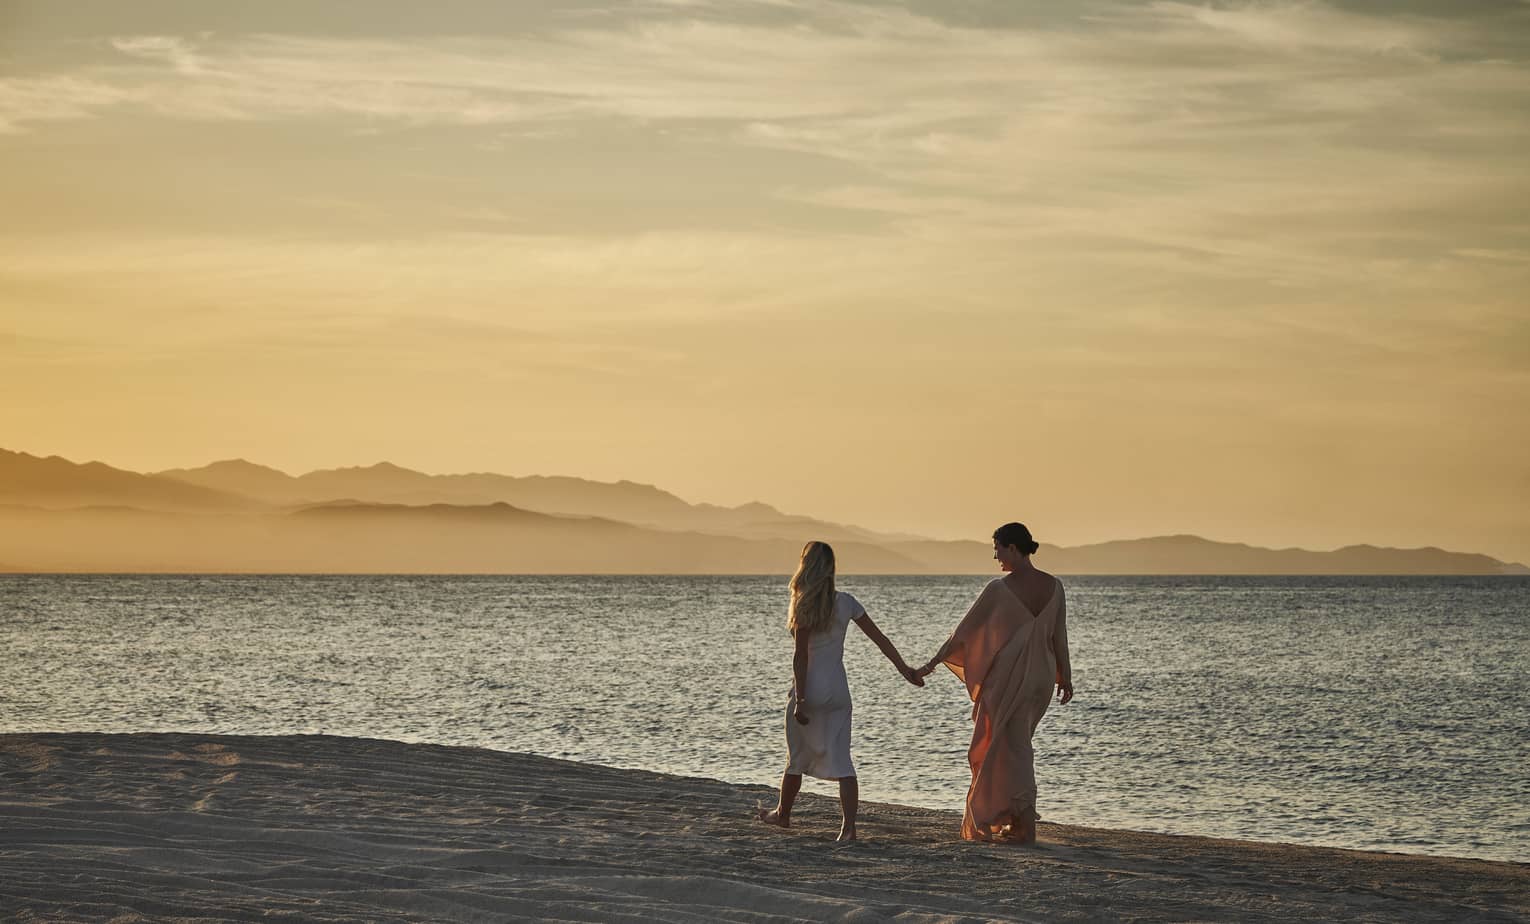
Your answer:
0,502 -> 924,574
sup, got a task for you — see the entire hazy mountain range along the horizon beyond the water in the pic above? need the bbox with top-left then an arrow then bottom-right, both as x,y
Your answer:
0,450 -> 1530,574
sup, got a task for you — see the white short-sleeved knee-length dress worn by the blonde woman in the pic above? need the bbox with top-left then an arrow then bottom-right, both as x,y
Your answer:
786,592 -> 866,780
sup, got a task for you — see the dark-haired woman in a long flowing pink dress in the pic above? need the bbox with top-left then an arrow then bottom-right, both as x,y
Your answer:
916,523 -> 1073,844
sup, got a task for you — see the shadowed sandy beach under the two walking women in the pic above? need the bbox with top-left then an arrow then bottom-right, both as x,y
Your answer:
0,734 -> 1530,922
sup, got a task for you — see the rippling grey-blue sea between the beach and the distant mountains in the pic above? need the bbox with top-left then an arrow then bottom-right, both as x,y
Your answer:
0,575 -> 1530,861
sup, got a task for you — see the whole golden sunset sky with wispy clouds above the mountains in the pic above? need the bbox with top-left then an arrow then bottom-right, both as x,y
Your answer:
0,0 -> 1530,561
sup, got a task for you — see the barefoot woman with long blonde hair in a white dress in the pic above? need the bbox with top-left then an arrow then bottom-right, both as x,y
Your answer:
757,542 -> 924,841
